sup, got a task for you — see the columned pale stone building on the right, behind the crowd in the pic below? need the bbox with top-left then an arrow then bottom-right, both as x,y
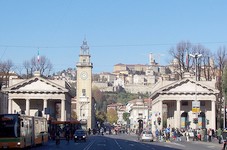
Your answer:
150,78 -> 219,131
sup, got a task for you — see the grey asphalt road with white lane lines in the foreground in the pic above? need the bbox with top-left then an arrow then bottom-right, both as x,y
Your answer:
32,134 -> 221,150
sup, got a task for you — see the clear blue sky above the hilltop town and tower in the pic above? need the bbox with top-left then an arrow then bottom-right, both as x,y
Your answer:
0,0 -> 227,73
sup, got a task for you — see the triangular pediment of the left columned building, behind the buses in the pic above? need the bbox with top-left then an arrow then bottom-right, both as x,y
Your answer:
5,77 -> 67,92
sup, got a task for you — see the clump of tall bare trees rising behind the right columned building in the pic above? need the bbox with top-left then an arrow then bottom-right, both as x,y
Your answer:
169,41 -> 212,80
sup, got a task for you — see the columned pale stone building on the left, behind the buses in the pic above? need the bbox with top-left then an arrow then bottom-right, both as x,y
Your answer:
4,71 -> 75,121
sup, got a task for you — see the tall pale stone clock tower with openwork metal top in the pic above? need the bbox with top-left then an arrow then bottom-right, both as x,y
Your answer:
76,40 -> 95,129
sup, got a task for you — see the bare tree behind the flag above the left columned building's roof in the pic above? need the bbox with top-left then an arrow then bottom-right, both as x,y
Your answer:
23,56 -> 53,78
